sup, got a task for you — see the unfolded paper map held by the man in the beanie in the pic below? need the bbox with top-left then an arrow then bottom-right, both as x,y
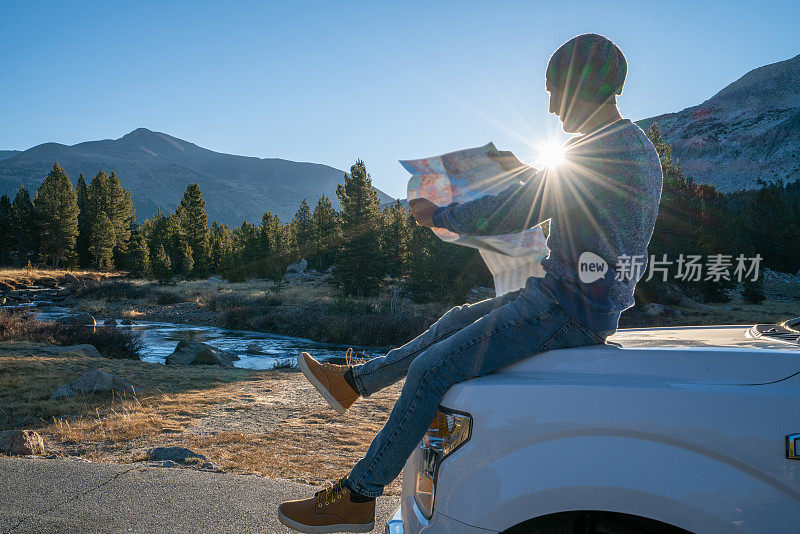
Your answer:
400,143 -> 548,296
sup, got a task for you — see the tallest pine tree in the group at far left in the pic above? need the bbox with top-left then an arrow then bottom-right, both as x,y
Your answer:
33,163 -> 78,268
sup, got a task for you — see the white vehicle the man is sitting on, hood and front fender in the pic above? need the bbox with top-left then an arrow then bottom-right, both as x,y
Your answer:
386,319 -> 800,534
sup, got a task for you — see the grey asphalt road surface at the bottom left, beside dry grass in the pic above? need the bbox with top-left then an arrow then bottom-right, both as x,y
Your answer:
0,457 -> 400,534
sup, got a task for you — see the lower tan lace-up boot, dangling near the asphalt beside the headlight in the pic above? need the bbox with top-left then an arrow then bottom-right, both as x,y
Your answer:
278,479 -> 375,533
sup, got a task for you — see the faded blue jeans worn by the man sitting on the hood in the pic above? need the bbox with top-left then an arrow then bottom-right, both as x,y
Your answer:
347,277 -> 611,497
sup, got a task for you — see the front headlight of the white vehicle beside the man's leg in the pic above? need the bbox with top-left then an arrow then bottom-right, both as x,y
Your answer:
414,406 -> 472,519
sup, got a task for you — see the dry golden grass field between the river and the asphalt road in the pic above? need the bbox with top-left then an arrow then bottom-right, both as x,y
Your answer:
0,342 -> 401,494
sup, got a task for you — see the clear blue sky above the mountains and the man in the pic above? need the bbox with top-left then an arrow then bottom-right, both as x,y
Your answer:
0,0 -> 800,196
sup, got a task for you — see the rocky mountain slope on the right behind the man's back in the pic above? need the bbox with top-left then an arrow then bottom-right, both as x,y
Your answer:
638,55 -> 800,192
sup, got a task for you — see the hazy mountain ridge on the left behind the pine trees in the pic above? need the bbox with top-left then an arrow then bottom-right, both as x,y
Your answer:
0,128 -> 392,226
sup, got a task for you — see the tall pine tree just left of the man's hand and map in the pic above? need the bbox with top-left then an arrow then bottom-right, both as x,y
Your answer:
335,160 -> 386,296
